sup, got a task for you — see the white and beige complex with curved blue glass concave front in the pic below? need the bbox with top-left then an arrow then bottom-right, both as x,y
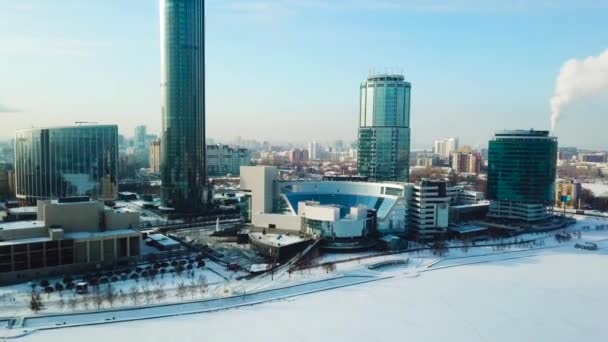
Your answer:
240,166 -> 411,239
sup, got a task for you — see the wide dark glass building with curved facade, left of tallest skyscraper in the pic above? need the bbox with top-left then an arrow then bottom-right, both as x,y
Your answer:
15,125 -> 118,203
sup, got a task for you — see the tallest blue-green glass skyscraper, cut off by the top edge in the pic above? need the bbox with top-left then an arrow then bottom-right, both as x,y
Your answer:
160,0 -> 206,212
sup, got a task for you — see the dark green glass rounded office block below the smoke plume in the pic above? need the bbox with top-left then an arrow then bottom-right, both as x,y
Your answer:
487,130 -> 557,222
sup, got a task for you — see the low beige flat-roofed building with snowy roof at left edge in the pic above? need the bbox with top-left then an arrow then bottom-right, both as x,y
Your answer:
0,197 -> 140,284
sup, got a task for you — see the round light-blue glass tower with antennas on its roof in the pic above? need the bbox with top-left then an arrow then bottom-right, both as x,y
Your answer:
357,75 -> 411,182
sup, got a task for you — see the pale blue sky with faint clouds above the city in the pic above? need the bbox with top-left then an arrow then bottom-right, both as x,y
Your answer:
0,0 -> 608,149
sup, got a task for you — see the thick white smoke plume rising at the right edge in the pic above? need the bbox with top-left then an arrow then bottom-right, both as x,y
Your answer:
550,49 -> 608,131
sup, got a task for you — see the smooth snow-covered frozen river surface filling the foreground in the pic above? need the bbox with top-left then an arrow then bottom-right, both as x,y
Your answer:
23,249 -> 608,342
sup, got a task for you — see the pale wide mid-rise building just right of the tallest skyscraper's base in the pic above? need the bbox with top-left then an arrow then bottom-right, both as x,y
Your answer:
206,144 -> 251,177
